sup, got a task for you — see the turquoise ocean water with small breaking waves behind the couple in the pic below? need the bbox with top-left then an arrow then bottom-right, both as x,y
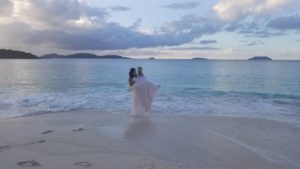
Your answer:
0,59 -> 300,122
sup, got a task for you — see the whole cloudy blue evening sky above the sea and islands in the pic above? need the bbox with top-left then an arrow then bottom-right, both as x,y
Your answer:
0,0 -> 300,60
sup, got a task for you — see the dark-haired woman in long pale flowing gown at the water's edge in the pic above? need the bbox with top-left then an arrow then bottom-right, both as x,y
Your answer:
128,68 -> 160,117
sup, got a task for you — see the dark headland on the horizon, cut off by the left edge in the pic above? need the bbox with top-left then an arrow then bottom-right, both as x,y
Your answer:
0,49 -> 39,59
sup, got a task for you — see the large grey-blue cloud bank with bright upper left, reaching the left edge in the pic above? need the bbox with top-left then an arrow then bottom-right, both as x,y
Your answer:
0,0 -> 219,50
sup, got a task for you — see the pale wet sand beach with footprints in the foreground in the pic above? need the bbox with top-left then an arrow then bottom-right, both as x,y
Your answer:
0,112 -> 300,169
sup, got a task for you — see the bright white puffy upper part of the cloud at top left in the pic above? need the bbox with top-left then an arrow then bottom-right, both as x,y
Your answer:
2,0 -> 106,29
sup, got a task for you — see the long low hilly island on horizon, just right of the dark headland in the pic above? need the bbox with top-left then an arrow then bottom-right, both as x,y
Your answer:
40,53 -> 130,59
